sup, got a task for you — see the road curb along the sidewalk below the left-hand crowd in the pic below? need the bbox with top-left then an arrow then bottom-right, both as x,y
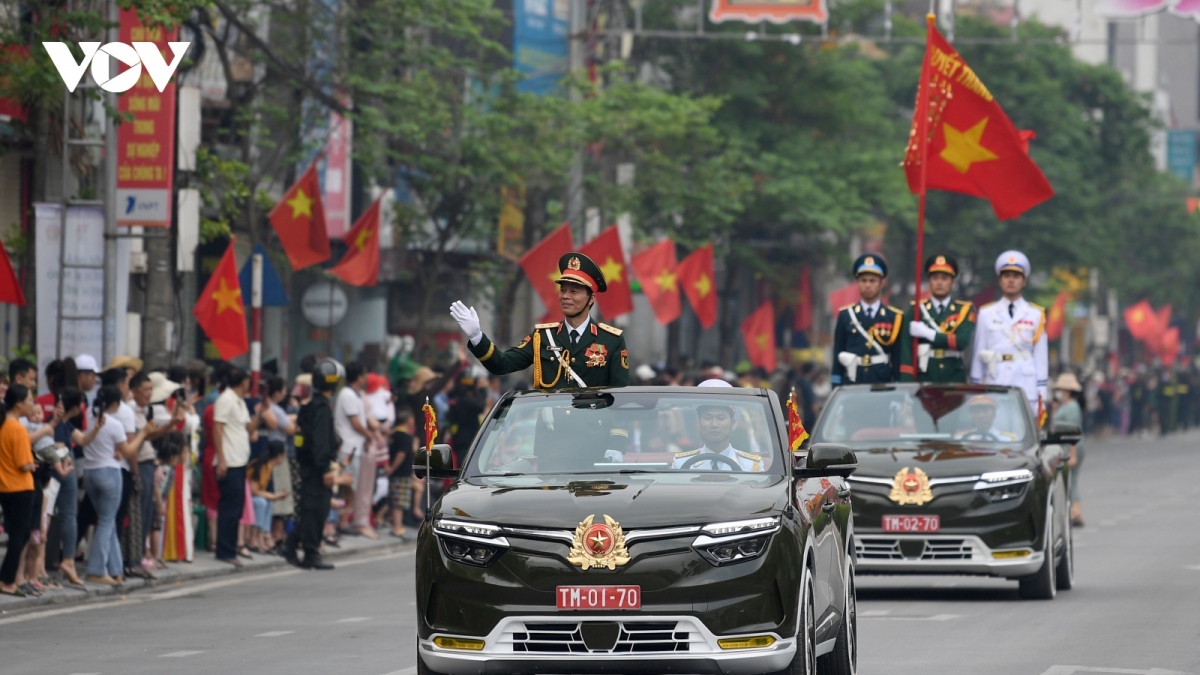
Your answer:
0,540 -> 416,616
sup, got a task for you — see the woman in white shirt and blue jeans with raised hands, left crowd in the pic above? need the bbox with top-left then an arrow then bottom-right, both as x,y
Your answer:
80,387 -> 156,586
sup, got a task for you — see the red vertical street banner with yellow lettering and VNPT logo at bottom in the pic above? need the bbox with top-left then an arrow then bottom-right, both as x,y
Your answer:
115,10 -> 179,227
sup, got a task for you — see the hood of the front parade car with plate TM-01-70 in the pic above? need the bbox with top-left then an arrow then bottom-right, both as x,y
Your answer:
437,473 -> 788,528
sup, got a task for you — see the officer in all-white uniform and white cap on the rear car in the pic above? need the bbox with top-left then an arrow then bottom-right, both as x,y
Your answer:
971,251 -> 1049,411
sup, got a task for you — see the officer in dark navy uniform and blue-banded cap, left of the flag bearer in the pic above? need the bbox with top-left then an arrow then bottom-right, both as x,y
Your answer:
830,253 -> 904,387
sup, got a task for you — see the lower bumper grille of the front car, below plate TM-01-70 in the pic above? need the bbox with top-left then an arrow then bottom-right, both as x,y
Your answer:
502,621 -> 691,653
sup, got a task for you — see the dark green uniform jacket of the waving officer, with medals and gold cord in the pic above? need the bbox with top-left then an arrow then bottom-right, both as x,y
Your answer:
470,321 -> 629,392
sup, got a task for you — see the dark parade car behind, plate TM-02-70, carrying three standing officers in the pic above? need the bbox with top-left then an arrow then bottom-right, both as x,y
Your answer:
812,383 -> 1079,599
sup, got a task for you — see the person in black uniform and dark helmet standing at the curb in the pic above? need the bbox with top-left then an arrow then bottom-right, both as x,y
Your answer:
283,359 -> 344,569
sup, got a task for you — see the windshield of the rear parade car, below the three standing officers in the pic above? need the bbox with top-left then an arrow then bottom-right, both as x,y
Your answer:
812,387 -> 1032,444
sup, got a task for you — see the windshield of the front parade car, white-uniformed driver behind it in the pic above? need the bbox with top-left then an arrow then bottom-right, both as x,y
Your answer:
466,390 -> 785,476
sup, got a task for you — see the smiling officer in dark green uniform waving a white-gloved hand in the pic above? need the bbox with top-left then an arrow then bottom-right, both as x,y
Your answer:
450,252 -> 629,392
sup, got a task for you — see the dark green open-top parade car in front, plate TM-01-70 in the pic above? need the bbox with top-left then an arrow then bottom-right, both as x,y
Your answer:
414,387 -> 857,675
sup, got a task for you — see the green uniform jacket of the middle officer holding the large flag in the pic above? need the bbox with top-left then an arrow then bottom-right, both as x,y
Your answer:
900,300 -> 976,382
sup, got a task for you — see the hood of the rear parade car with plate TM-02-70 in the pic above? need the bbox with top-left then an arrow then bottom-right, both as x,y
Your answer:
852,441 -> 1037,478
